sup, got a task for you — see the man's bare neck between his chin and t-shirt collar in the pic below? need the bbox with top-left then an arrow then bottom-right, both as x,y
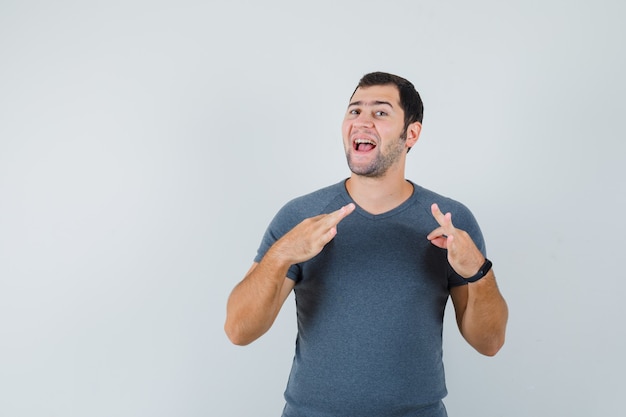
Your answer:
346,171 -> 413,214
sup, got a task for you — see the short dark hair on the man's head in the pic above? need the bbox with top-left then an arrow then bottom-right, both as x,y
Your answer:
352,72 -> 424,132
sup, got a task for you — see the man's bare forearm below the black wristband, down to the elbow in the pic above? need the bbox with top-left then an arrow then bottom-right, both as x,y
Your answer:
460,271 -> 508,356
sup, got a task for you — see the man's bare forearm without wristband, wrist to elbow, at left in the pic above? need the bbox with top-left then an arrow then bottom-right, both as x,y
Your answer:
224,249 -> 290,345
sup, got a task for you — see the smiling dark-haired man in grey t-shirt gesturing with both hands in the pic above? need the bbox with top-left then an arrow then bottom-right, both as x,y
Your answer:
225,73 -> 508,417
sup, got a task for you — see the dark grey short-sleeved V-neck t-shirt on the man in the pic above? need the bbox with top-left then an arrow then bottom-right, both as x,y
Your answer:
255,181 -> 485,417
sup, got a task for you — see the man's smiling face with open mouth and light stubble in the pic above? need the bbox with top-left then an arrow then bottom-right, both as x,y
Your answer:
342,85 -> 407,178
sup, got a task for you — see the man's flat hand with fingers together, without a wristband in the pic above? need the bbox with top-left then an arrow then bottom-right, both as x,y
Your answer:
272,203 -> 355,265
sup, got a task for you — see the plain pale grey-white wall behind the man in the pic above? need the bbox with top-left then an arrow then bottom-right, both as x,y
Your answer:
0,0 -> 626,417
